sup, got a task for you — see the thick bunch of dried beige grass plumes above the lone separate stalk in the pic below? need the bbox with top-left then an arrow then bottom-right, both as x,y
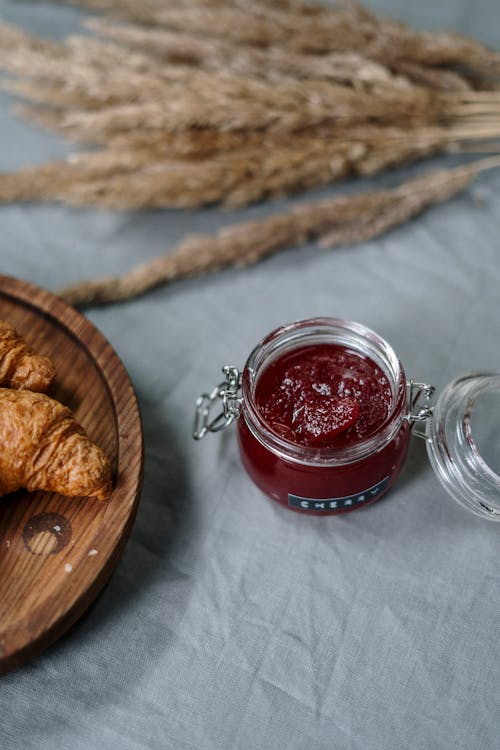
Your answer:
0,0 -> 500,209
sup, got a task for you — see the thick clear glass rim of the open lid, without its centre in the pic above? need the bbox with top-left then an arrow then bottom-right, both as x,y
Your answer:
426,373 -> 500,521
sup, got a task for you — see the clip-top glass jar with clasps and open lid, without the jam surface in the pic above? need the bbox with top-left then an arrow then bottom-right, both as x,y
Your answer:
193,318 -> 500,520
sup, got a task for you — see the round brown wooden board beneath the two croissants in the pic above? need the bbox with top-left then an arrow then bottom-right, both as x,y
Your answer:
0,275 -> 143,674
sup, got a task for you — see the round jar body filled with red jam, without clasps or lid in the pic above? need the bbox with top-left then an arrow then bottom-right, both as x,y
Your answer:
238,318 -> 410,515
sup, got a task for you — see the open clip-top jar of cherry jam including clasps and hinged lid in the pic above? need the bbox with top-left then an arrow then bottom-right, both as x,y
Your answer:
193,318 -> 500,520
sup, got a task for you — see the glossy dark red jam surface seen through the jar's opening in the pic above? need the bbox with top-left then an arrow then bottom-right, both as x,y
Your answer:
255,344 -> 392,448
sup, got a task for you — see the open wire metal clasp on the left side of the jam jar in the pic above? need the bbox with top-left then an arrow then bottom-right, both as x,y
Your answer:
193,365 -> 243,440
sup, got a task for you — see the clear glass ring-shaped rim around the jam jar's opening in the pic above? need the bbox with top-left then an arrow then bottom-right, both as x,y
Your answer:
242,317 -> 408,466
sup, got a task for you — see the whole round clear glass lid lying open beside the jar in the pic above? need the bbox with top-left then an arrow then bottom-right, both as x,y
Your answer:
426,374 -> 500,521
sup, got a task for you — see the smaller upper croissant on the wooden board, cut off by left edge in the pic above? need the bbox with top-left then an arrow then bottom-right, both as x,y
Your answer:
0,320 -> 55,392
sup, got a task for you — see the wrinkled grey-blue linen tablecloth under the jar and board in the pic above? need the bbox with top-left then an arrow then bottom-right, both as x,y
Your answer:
0,0 -> 500,750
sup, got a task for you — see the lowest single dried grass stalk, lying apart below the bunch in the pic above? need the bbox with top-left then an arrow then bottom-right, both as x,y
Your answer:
59,158 -> 500,306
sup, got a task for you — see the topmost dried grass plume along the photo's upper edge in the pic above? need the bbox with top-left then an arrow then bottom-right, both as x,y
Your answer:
63,0 -> 500,78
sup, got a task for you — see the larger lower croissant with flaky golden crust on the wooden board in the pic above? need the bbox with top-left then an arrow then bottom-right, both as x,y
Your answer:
0,388 -> 112,500
